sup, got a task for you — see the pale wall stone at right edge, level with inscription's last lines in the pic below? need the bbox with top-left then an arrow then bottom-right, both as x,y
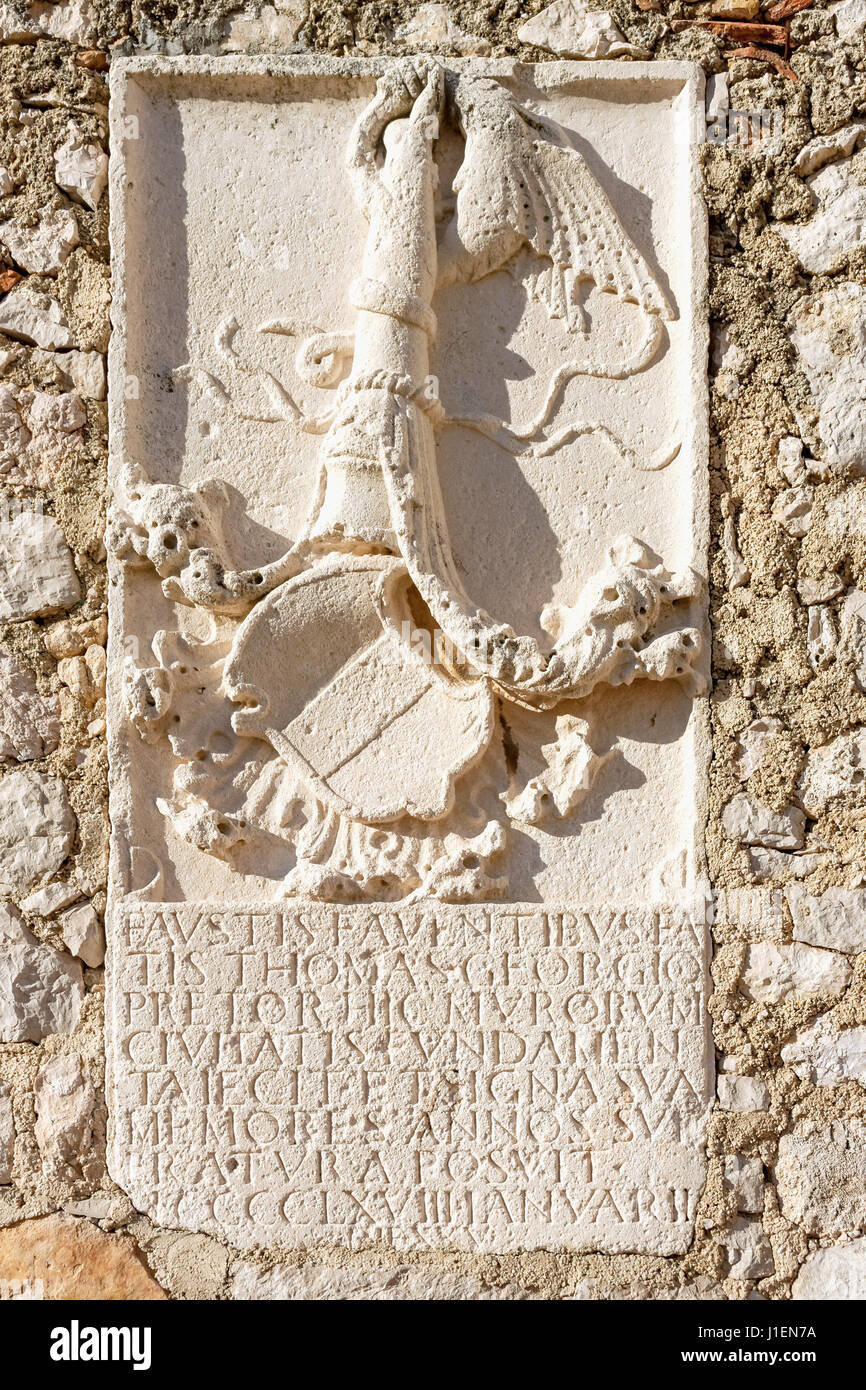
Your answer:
776,1120 -> 866,1236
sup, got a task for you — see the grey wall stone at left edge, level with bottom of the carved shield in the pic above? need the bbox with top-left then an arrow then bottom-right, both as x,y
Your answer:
0,771 -> 75,892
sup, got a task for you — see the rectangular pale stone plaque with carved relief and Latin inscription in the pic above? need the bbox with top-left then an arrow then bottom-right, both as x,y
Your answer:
108,58 -> 709,1254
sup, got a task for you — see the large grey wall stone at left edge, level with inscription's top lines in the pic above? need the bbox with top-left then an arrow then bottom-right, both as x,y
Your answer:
0,904 -> 83,1043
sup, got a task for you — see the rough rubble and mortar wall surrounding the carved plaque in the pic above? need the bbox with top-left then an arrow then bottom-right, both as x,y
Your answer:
0,0 -> 866,1300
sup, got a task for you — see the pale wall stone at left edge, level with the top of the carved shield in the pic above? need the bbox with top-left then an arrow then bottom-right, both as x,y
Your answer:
0,512 -> 81,620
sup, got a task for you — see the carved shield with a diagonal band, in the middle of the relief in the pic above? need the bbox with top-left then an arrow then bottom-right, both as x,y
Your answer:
224,555 -> 493,823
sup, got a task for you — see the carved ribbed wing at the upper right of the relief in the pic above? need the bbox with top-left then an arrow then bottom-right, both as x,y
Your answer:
439,76 -> 673,332
